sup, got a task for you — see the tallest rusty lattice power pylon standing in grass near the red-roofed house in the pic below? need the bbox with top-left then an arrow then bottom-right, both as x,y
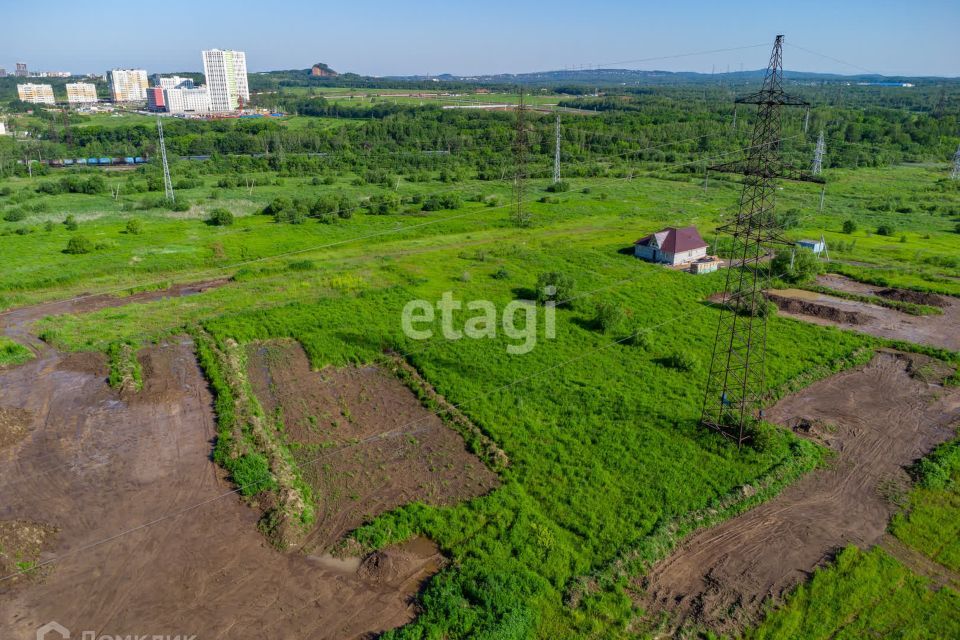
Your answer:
701,35 -> 809,447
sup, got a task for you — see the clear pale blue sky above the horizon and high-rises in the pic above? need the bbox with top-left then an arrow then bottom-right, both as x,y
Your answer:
0,0 -> 960,76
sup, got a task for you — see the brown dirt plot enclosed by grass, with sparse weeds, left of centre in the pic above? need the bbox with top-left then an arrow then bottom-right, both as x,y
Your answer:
248,342 -> 499,550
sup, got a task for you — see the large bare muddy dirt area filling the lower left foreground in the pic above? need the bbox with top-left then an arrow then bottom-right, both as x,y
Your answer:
0,341 -> 443,640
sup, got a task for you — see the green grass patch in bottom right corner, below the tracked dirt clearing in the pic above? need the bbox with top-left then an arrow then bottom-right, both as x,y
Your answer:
744,547 -> 960,640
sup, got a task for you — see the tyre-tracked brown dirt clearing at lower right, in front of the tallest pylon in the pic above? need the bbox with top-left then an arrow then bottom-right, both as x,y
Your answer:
642,352 -> 960,633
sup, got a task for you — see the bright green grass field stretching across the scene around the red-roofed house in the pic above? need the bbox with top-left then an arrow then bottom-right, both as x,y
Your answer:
0,152 -> 960,638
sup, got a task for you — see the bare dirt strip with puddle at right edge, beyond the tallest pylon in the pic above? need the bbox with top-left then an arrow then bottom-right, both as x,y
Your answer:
768,276 -> 960,351
